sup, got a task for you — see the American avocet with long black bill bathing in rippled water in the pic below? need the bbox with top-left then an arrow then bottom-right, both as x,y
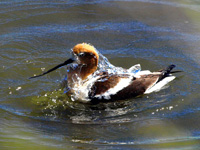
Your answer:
31,43 -> 175,102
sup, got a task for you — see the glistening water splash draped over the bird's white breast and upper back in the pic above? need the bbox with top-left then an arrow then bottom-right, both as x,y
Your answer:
65,50 -> 141,102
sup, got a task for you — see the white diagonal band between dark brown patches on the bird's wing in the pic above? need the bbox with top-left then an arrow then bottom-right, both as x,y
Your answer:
95,76 -> 133,99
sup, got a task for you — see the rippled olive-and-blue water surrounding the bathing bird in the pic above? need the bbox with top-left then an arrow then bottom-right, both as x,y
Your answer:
0,0 -> 200,150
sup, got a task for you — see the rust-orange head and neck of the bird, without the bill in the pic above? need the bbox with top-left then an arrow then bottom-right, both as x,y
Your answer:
73,43 -> 99,79
